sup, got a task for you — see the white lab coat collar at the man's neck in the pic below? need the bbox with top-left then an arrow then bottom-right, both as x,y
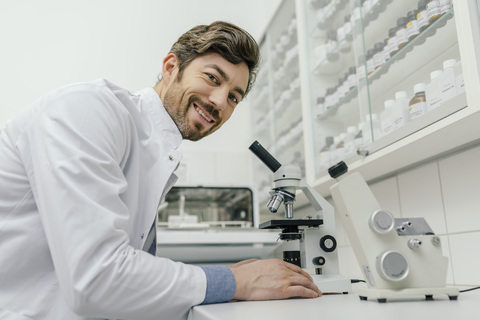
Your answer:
137,87 -> 183,149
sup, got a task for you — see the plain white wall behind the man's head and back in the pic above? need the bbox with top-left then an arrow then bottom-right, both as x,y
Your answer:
0,0 -> 278,183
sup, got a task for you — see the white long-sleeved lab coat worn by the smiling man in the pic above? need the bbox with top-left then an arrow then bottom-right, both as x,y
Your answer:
0,80 -> 206,320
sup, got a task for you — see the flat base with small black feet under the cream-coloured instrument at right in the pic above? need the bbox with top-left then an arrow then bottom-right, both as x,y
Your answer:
358,287 -> 459,303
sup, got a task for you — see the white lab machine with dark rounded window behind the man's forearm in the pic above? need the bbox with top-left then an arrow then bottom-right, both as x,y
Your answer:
157,186 -> 278,264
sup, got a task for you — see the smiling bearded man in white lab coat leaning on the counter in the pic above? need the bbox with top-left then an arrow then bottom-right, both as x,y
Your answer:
0,22 -> 321,320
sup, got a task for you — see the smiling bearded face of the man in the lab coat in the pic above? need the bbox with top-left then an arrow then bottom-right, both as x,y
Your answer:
163,53 -> 249,141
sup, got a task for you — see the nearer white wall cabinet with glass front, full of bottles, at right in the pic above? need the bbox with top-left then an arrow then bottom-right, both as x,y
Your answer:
249,0 -> 480,215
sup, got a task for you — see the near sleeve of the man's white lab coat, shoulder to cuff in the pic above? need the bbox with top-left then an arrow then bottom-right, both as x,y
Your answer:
17,85 -> 206,320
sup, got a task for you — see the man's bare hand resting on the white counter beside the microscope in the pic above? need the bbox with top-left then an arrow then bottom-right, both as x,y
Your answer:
230,259 -> 322,300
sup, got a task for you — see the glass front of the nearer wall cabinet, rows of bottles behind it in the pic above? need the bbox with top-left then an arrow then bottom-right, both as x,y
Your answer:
299,0 -> 466,179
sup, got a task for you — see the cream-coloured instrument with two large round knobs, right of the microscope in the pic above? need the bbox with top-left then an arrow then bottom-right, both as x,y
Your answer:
329,162 -> 459,302
